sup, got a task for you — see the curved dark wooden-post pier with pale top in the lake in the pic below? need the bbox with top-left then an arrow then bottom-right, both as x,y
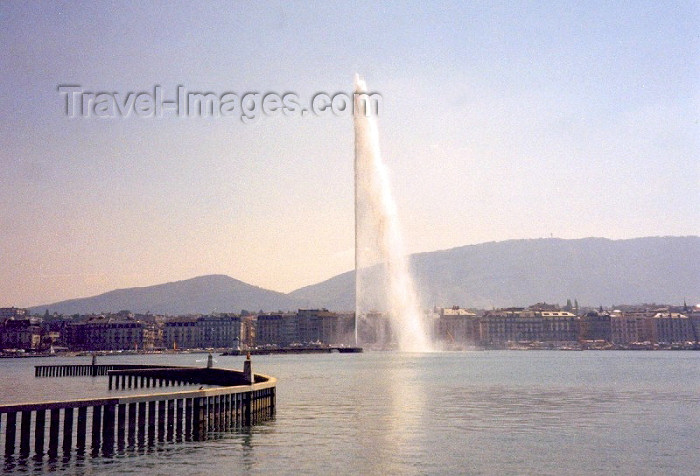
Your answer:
0,365 -> 276,460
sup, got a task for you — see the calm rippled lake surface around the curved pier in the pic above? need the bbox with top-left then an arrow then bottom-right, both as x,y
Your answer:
0,351 -> 700,475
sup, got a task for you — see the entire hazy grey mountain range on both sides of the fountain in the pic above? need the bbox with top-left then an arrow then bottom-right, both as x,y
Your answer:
31,236 -> 700,314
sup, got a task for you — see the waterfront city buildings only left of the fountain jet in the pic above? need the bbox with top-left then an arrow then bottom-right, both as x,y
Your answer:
0,308 -> 354,351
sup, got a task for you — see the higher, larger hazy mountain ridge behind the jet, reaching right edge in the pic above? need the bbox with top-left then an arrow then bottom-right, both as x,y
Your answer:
289,236 -> 700,309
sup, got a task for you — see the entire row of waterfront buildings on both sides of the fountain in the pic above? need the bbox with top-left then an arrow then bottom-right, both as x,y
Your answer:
0,303 -> 700,351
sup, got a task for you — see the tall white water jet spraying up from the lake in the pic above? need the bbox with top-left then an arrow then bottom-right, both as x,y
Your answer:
354,75 -> 431,352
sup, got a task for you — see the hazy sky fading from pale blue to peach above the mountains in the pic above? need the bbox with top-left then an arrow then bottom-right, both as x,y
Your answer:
0,1 -> 700,306
